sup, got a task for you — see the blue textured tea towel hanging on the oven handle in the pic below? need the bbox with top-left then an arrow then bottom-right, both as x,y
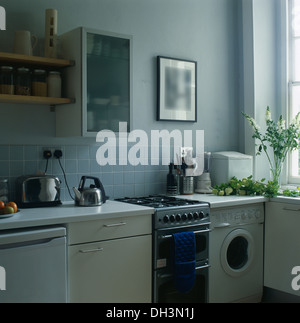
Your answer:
173,231 -> 196,293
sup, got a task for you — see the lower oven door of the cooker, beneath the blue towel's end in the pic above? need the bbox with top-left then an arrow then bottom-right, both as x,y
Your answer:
153,262 -> 209,303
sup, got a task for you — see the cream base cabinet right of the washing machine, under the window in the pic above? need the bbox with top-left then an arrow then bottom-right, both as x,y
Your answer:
264,202 -> 300,296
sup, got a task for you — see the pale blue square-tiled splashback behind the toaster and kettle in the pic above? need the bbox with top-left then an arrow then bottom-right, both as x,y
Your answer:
0,145 -> 168,201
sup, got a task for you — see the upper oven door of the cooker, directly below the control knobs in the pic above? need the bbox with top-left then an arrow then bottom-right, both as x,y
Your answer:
153,224 -> 210,272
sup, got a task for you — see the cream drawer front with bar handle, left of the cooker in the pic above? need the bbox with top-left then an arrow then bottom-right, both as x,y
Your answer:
68,215 -> 151,245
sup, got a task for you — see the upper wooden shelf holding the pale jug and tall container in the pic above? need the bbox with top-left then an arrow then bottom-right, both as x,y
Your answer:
0,52 -> 75,68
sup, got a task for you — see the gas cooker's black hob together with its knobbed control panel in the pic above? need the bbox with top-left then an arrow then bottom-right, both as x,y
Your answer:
116,195 -> 209,229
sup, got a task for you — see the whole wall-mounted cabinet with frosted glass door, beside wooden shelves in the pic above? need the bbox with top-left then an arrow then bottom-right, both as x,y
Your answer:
56,27 -> 132,137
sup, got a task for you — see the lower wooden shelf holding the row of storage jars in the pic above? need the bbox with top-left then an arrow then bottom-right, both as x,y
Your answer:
0,94 -> 74,105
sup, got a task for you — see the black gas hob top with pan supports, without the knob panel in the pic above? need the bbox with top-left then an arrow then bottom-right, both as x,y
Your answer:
116,195 -> 207,209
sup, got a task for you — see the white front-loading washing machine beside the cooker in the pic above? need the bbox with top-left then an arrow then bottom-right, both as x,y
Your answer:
209,203 -> 264,303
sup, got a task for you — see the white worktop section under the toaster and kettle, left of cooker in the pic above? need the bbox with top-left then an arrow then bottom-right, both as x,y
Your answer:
0,200 -> 154,230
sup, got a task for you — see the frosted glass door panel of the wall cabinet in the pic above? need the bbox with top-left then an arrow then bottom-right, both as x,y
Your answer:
86,32 -> 130,132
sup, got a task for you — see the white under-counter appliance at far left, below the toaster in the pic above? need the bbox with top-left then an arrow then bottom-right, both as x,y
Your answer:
0,227 -> 67,303
